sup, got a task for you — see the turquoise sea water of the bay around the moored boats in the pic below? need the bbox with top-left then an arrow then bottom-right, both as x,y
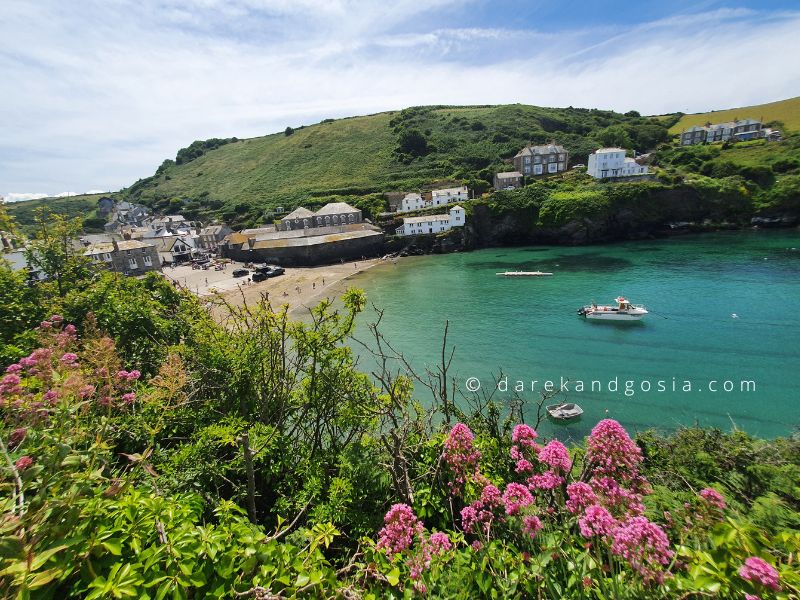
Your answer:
350,231 -> 800,439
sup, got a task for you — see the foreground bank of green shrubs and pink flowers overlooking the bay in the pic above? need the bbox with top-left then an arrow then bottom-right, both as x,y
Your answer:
0,237 -> 800,599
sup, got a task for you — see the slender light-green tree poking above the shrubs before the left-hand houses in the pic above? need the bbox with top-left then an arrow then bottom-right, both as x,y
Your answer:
25,208 -> 90,298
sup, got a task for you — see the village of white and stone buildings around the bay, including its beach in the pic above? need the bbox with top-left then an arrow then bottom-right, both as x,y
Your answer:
3,118 -> 781,314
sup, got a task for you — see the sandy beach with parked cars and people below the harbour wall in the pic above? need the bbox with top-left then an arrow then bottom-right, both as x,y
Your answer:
163,258 -> 385,319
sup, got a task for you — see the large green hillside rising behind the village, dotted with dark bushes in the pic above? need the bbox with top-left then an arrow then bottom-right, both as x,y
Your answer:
123,105 -> 677,225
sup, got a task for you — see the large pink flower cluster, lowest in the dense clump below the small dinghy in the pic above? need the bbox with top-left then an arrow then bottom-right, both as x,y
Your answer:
612,509 -> 674,583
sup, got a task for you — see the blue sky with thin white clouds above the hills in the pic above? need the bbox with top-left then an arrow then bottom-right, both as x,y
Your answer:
0,0 -> 800,201
